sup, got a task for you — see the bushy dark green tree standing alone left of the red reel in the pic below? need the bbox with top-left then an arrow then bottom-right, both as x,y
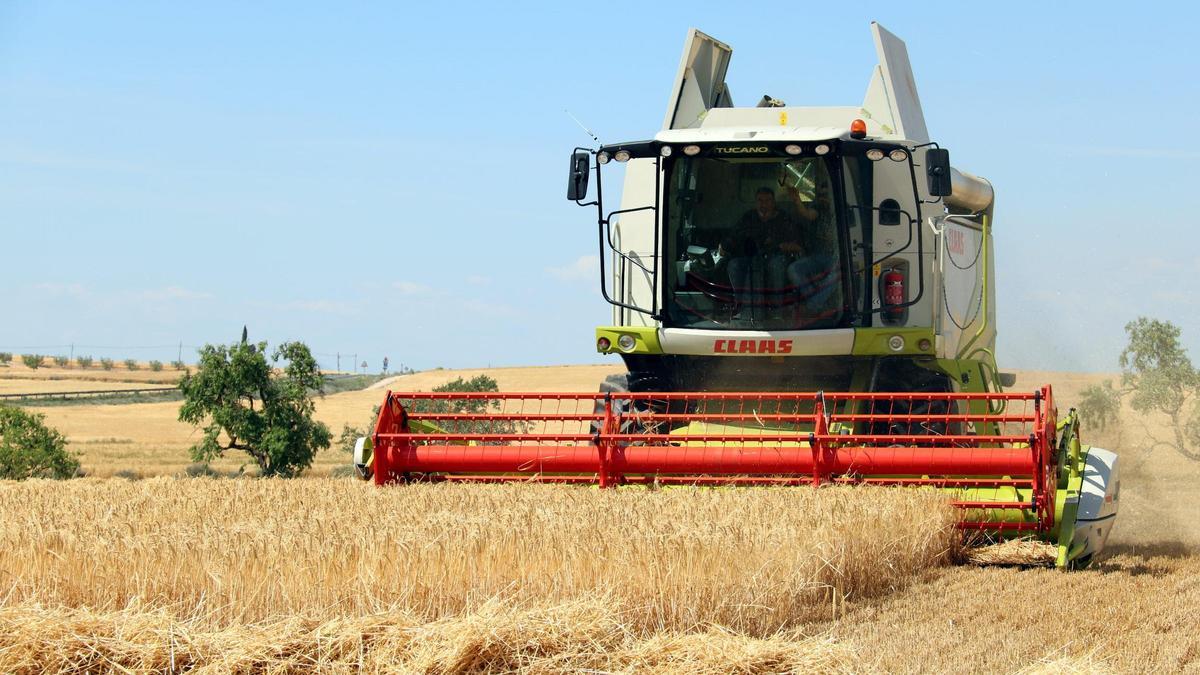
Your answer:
179,339 -> 331,477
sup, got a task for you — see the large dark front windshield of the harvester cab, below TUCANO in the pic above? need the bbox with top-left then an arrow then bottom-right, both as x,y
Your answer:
665,156 -> 846,330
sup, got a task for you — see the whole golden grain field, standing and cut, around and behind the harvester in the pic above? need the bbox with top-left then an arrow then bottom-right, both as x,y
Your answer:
0,366 -> 1200,673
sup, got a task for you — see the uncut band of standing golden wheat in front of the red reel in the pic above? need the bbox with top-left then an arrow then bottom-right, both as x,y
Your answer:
0,478 -> 956,637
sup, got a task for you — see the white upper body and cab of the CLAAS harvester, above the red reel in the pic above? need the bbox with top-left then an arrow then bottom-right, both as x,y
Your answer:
580,24 -> 1003,392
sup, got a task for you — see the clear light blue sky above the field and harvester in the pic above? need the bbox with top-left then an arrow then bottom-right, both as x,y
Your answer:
0,1 -> 1200,370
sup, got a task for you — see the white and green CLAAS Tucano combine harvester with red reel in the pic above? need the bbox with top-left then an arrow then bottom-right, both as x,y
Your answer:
355,24 -> 1120,567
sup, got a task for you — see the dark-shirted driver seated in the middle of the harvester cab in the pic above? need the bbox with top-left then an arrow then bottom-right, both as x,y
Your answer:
720,187 -> 820,318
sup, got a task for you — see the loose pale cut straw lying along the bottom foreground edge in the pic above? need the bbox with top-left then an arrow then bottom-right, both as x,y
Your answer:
0,601 -> 863,674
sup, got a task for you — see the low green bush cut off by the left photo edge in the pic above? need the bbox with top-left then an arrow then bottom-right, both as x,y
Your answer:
0,406 -> 79,480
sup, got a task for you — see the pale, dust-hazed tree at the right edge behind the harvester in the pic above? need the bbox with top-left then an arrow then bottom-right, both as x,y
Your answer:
1080,317 -> 1200,461
